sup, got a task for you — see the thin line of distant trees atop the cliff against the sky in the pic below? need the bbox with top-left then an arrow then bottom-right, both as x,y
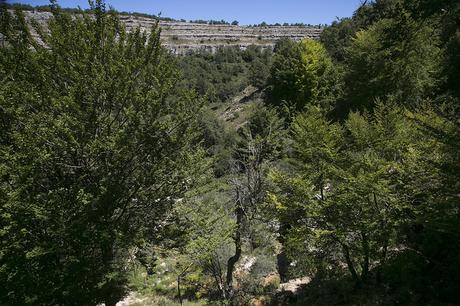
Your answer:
6,3 -> 327,29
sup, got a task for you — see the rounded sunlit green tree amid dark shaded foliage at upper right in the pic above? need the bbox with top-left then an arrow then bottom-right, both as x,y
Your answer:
345,6 -> 441,109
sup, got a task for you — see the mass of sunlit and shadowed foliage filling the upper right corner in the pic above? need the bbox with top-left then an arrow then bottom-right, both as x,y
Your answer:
321,0 -> 459,114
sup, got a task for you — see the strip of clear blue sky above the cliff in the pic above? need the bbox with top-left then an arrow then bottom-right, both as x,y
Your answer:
7,0 -> 362,25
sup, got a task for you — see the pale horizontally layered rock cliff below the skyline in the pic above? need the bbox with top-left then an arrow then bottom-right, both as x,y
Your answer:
16,11 -> 322,54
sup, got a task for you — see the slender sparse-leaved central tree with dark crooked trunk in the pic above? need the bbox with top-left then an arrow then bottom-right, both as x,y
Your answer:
226,106 -> 283,299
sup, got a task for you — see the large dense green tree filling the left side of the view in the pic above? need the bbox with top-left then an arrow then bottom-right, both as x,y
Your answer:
0,1 -> 201,305
